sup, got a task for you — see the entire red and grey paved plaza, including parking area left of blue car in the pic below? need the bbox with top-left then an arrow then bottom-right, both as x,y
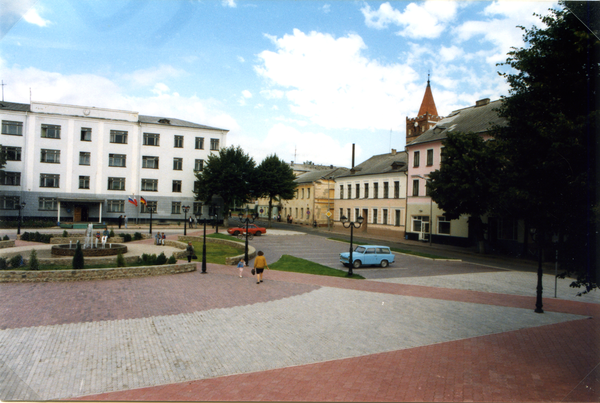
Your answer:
0,231 -> 600,402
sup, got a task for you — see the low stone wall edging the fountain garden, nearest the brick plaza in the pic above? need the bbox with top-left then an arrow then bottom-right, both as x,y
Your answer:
0,263 -> 196,283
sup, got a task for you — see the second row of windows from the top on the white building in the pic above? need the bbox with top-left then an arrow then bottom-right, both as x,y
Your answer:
2,146 -> 204,171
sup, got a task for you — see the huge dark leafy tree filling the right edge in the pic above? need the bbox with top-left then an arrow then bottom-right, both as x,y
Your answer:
496,1 -> 600,289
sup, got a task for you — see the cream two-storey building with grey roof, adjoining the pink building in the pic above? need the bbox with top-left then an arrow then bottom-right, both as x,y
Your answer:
334,150 -> 407,238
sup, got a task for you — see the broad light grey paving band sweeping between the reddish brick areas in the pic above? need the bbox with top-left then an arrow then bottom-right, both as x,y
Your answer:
0,287 -> 582,400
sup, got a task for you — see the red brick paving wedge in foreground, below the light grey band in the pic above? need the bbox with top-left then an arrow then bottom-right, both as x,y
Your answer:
79,319 -> 600,402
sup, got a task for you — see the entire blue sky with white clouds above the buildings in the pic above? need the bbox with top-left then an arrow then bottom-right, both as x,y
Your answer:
0,0 -> 558,167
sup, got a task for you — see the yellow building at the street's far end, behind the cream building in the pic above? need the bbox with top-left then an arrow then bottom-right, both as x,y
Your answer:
282,168 -> 348,226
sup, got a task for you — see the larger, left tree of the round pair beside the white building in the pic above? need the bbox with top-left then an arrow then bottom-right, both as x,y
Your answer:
194,146 -> 256,226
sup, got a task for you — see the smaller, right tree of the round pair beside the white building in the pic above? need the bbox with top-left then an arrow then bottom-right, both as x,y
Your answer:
256,154 -> 296,228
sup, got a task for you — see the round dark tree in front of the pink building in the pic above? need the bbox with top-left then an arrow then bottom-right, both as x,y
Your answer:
427,132 -> 502,252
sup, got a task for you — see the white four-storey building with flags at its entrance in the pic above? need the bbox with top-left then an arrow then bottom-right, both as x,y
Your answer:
0,102 -> 228,222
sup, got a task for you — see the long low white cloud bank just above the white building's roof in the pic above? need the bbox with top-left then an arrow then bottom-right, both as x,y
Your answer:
0,59 -> 239,130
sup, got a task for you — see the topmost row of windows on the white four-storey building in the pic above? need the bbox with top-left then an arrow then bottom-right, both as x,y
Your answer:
2,120 -> 220,151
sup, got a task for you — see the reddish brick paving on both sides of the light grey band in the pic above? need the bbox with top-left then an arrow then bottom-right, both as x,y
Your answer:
0,252 -> 600,402
